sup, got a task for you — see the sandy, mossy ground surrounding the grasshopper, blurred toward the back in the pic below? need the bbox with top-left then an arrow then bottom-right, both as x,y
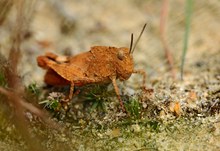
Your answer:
0,0 -> 220,151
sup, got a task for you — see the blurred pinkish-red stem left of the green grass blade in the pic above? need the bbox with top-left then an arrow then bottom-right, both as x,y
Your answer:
160,0 -> 176,79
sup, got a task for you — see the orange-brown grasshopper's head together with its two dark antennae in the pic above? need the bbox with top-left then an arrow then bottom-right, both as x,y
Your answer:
116,24 -> 147,81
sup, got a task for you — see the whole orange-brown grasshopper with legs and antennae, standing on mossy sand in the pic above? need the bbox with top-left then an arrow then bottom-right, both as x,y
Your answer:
37,24 -> 146,111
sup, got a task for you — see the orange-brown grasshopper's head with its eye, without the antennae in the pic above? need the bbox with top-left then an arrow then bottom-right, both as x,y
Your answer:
116,47 -> 134,81
